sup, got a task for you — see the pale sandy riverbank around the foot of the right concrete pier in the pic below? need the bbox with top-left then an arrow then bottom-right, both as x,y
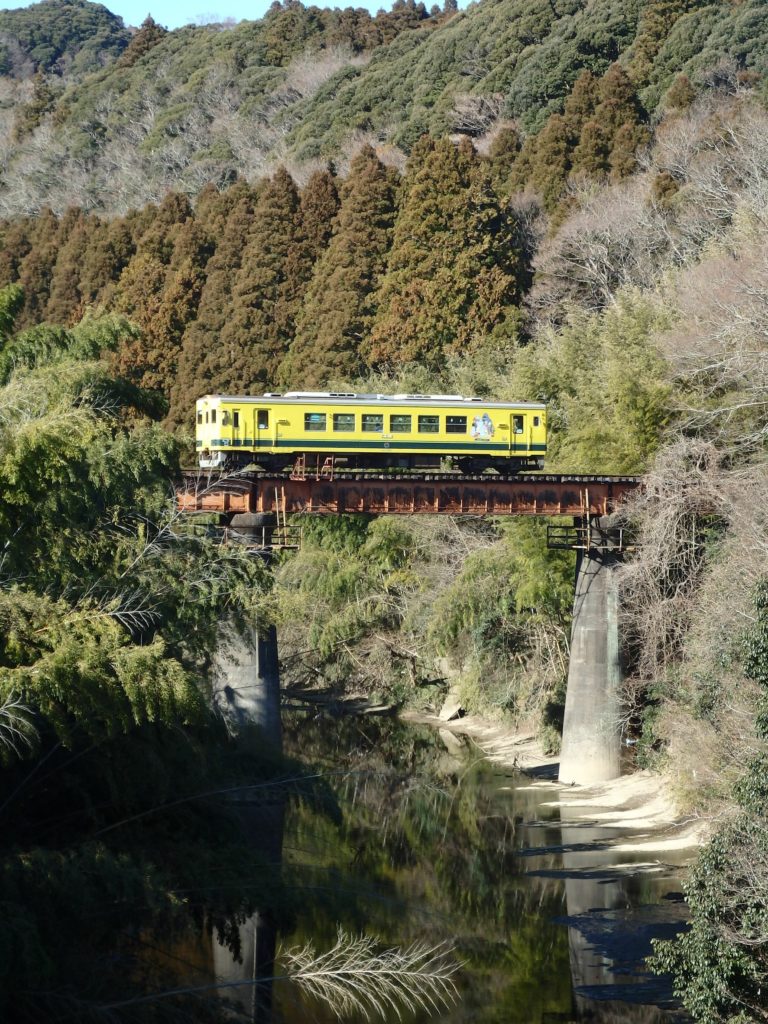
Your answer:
402,713 -> 710,857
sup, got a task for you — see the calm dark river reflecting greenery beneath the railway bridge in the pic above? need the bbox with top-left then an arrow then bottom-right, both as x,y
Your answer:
218,713 -> 686,1024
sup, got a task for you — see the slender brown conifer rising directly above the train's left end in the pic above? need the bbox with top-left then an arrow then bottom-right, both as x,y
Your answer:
215,168 -> 311,392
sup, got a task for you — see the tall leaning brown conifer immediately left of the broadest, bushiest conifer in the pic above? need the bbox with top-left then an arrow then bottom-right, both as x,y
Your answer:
280,145 -> 396,387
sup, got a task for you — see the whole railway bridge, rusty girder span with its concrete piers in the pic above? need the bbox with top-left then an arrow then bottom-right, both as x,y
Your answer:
176,470 -> 641,784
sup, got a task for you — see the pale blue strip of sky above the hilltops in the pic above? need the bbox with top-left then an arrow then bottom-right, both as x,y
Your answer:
0,0 -> 392,29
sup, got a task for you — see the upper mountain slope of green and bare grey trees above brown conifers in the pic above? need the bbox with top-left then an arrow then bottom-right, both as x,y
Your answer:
0,0 -> 768,216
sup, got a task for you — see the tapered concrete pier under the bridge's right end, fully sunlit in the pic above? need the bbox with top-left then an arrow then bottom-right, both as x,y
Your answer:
559,528 -> 622,785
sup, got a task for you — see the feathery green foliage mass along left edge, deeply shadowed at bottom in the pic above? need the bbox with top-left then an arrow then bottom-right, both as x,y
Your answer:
0,301 -> 286,1022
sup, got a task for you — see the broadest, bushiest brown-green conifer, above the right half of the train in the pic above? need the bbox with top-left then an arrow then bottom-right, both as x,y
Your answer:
365,137 -> 521,369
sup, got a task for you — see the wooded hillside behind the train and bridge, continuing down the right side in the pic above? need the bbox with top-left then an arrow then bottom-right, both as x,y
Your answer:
0,0 -> 768,1021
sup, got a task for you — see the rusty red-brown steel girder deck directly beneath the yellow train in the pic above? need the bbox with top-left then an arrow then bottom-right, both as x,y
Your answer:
176,472 -> 640,516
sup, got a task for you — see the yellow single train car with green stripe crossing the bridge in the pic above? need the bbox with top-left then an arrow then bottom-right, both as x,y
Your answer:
197,391 -> 547,472
